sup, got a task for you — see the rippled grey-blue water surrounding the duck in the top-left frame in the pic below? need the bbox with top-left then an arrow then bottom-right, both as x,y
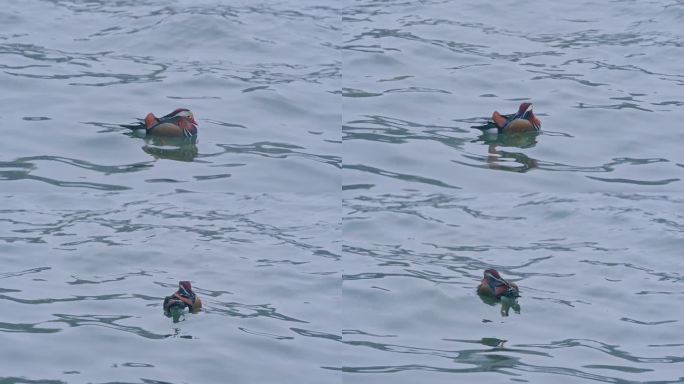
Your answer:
0,0 -> 341,192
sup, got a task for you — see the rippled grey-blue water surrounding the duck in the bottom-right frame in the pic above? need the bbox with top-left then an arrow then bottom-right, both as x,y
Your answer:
343,192 -> 684,383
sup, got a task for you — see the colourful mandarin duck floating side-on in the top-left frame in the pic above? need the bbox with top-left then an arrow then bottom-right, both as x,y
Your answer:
121,108 -> 197,137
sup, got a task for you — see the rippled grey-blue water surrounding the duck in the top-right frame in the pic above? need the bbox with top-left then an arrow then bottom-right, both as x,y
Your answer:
342,1 -> 684,193
